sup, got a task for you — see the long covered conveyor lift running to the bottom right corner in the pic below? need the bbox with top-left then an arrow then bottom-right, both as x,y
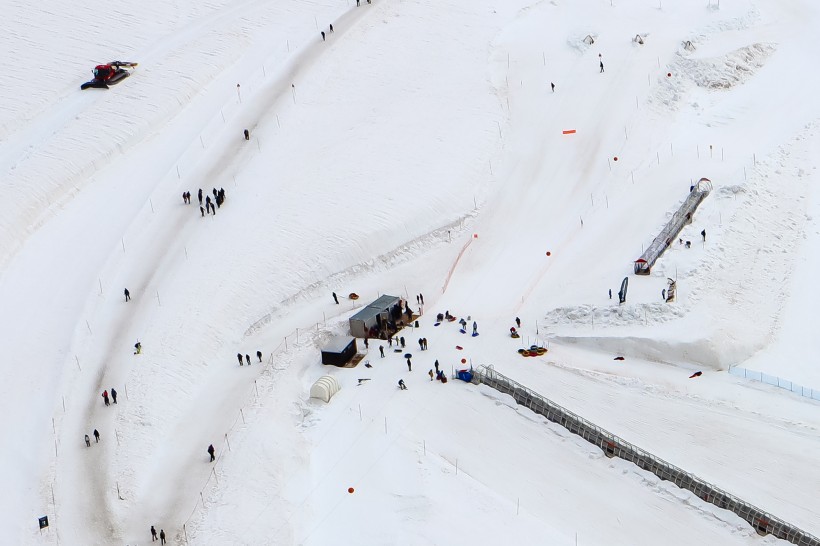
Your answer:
472,366 -> 820,546
